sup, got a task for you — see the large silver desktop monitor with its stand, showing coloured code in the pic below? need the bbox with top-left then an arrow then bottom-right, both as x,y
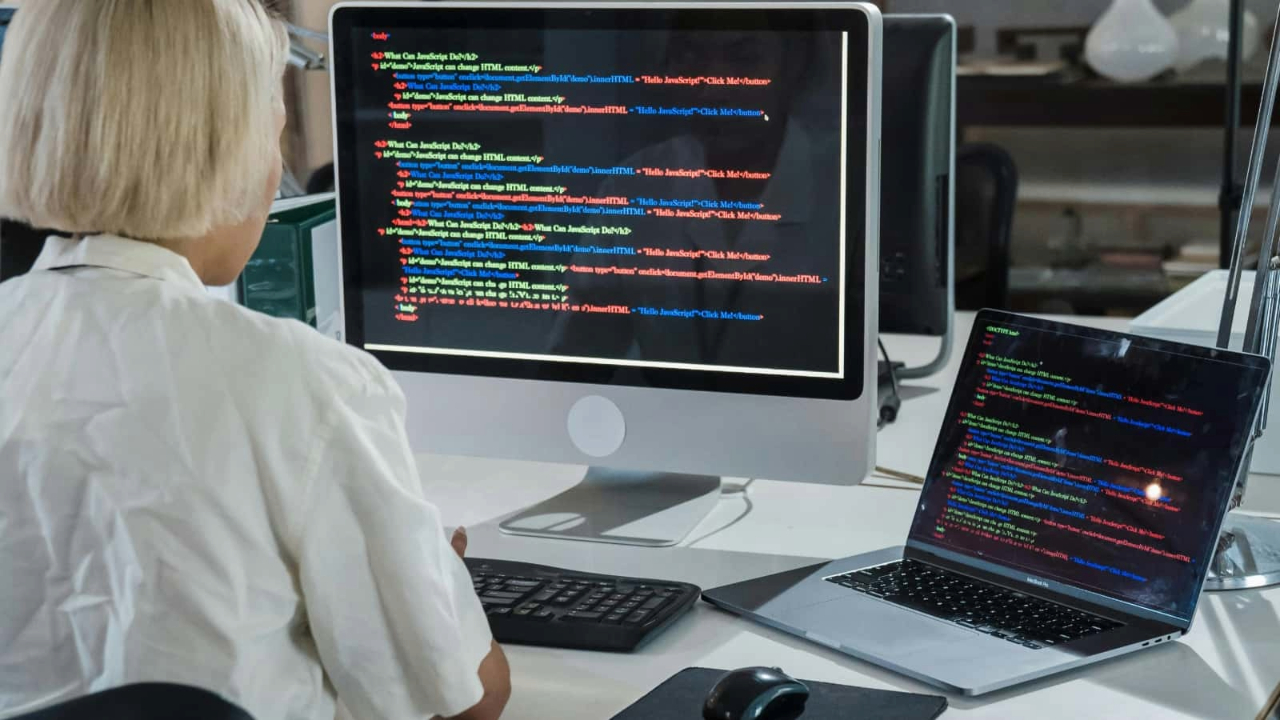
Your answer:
330,3 -> 881,544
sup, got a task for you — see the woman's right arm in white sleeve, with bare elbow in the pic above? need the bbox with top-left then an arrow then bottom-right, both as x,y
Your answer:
296,360 -> 509,720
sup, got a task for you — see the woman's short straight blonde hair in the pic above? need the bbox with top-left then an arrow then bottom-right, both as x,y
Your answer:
0,0 -> 289,240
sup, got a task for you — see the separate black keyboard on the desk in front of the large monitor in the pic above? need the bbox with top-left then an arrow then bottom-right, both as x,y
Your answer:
466,557 -> 703,652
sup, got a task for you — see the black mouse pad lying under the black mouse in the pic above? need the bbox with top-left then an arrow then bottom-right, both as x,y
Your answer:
613,667 -> 947,720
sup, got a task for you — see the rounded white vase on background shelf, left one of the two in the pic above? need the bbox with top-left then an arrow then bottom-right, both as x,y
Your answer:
1084,0 -> 1182,82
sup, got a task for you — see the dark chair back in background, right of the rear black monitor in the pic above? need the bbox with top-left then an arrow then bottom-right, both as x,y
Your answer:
956,143 -> 1018,310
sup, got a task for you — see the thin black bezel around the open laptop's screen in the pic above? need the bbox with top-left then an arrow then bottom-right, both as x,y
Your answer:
906,309 -> 1271,630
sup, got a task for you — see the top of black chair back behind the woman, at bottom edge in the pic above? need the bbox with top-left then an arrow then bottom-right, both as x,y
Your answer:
13,683 -> 253,720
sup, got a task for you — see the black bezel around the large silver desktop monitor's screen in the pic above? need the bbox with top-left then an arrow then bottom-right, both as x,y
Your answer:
330,1 -> 879,401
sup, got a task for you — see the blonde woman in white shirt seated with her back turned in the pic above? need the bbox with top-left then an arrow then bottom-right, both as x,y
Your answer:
0,0 -> 509,720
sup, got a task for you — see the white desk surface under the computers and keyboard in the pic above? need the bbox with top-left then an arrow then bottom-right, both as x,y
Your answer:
419,314 -> 1280,720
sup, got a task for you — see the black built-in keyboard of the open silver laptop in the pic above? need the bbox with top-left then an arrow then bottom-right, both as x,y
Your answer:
827,560 -> 1121,650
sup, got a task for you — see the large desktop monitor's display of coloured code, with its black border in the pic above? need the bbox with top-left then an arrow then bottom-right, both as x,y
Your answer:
335,9 -> 867,397
